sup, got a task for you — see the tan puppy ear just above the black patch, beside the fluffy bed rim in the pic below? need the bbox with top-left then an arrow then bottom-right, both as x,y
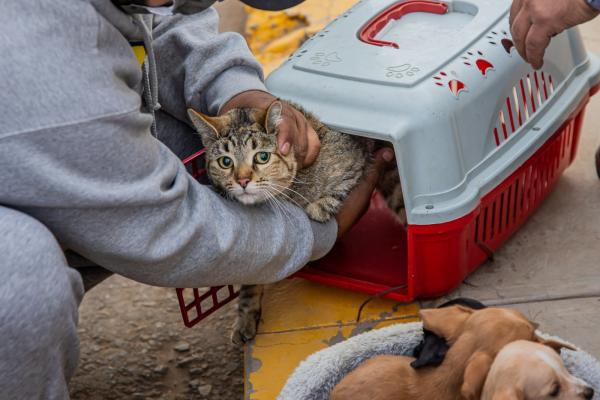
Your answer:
419,306 -> 475,342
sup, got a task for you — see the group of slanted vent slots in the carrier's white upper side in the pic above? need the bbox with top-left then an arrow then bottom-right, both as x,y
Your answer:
492,71 -> 554,146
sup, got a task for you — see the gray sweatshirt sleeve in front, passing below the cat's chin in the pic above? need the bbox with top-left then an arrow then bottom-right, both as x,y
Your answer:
0,111 -> 337,287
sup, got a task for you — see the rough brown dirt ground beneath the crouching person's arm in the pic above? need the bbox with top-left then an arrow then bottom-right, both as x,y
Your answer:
70,276 -> 243,400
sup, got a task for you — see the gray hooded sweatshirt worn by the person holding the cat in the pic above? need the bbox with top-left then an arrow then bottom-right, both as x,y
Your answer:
0,0 -> 336,287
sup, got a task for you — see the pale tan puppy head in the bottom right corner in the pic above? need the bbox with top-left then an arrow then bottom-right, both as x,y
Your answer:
481,340 -> 594,400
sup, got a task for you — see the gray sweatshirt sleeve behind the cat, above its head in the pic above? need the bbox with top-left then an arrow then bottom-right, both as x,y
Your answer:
153,8 -> 266,121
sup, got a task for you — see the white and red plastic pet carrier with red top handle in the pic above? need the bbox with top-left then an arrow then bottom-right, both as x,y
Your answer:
176,0 -> 600,326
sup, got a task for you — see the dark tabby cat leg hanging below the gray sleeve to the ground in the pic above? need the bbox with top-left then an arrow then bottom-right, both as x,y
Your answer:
231,285 -> 264,345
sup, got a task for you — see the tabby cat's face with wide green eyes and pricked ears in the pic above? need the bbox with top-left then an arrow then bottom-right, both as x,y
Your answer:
188,102 -> 297,204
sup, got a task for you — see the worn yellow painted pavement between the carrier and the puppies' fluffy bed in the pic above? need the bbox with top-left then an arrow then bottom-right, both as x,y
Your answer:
244,279 -> 419,400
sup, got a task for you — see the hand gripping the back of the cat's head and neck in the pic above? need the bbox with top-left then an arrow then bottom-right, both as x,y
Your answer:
219,90 -> 321,168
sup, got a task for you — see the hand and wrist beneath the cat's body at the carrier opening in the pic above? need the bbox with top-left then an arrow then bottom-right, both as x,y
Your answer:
335,147 -> 394,239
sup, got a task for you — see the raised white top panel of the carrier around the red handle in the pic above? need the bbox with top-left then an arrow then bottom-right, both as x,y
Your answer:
293,0 -> 502,87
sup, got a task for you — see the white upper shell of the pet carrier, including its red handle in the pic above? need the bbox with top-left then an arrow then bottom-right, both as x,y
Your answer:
267,0 -> 600,225
